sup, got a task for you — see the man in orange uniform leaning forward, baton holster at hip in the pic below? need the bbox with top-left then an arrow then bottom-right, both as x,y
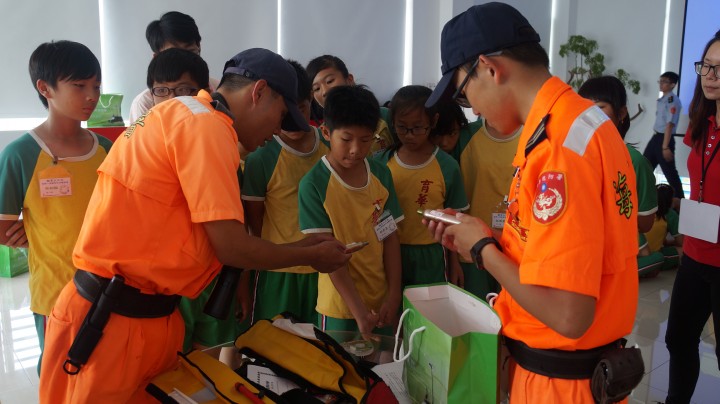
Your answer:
40,49 -> 349,403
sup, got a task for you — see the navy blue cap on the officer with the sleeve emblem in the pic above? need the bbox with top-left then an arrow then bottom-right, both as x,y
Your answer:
425,2 -> 540,108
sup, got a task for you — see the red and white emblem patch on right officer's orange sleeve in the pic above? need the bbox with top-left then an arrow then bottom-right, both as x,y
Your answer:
533,171 -> 567,224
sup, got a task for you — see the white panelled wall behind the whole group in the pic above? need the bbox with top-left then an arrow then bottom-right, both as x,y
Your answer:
0,0 -> 694,178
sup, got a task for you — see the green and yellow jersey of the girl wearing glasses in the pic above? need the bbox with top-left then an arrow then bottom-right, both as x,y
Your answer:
378,147 -> 468,245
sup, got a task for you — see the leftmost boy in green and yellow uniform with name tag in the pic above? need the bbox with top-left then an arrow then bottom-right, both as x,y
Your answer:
0,41 -> 112,374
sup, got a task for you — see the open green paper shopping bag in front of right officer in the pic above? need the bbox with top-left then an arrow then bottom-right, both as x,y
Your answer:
402,283 -> 501,404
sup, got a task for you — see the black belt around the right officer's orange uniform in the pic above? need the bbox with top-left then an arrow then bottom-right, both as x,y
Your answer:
505,337 -> 622,380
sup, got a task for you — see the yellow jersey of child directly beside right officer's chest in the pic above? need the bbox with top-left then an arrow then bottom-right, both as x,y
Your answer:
456,119 -> 522,224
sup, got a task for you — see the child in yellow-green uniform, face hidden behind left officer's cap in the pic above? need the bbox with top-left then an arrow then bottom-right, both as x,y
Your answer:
242,61 -> 329,323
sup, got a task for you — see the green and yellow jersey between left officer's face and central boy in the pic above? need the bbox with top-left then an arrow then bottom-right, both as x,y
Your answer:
241,128 -> 329,273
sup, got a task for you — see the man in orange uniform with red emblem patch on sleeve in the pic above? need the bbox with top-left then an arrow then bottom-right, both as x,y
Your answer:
426,3 -> 642,403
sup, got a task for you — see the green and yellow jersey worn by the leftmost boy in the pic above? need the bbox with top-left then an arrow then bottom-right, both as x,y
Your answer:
0,131 -> 112,316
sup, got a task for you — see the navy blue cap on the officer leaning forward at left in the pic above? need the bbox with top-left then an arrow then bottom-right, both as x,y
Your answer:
223,48 -> 310,132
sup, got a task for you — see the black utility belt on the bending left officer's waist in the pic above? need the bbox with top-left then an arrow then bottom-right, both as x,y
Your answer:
73,269 -> 180,318
